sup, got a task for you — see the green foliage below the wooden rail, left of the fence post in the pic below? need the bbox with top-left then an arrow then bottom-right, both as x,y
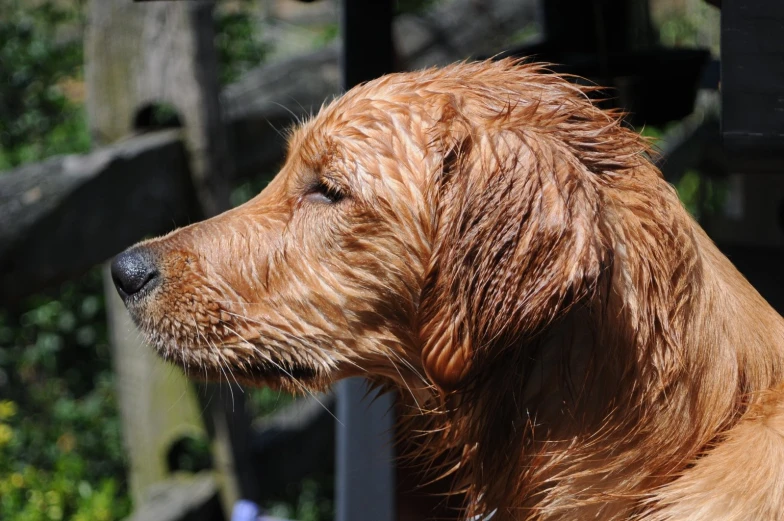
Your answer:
0,270 -> 130,521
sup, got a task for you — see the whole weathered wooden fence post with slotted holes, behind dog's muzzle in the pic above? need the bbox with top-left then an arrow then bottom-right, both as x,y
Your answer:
85,0 -> 256,517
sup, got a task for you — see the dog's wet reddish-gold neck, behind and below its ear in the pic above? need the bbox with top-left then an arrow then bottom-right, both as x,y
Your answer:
422,173 -> 784,520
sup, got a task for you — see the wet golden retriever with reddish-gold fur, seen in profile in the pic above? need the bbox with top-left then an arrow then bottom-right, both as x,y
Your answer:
113,60 -> 784,521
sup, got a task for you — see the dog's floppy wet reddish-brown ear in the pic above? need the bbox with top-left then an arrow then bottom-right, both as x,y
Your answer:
419,110 -> 605,391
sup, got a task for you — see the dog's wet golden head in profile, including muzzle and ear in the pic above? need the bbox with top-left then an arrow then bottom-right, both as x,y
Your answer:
112,61 -> 644,390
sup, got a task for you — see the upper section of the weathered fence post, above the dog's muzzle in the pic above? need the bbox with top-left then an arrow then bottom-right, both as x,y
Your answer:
85,0 -> 232,215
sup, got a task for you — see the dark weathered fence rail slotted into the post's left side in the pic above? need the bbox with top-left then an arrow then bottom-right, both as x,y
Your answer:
0,130 -> 198,302
